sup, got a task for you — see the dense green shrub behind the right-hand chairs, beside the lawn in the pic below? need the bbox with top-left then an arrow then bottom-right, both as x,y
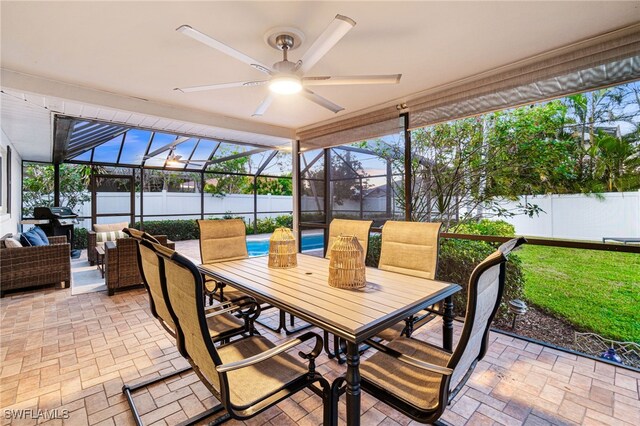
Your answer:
366,230 -> 524,317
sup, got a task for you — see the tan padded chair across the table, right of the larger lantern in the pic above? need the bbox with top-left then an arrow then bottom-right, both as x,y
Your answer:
378,221 -> 442,341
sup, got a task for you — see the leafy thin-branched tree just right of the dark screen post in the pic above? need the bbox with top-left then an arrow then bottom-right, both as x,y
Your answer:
365,101 -> 576,228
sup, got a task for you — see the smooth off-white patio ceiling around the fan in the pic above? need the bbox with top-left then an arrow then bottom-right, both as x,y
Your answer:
0,1 -> 640,160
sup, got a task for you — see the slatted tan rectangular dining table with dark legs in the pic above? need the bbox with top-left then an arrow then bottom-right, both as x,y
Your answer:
199,254 -> 461,425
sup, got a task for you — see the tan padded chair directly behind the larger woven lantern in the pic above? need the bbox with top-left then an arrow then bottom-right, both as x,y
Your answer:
324,219 -> 373,364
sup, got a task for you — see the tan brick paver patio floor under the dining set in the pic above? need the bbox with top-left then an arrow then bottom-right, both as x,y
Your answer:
0,253 -> 640,426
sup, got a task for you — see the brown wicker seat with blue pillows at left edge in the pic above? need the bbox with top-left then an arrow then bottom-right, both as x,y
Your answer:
0,234 -> 71,297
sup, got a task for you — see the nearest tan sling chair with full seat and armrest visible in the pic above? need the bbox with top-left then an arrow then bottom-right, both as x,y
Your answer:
161,248 -> 331,424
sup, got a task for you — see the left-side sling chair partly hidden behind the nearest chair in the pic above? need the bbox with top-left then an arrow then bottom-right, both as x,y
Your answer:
122,233 -> 259,426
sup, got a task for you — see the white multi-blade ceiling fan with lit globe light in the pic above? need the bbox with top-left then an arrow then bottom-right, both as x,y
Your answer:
175,15 -> 402,116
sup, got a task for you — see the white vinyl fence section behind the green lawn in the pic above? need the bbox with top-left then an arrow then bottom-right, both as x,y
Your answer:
502,191 -> 640,241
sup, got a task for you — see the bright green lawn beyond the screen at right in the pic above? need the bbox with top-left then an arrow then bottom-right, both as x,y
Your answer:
517,245 -> 640,342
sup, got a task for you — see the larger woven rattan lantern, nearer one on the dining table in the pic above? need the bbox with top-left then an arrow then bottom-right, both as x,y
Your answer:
329,235 -> 367,288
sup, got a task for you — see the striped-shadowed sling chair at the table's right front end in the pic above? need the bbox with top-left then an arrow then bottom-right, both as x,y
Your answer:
332,238 -> 526,423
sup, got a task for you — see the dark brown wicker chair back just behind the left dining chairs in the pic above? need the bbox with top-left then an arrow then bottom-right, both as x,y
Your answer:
104,235 -> 175,296
